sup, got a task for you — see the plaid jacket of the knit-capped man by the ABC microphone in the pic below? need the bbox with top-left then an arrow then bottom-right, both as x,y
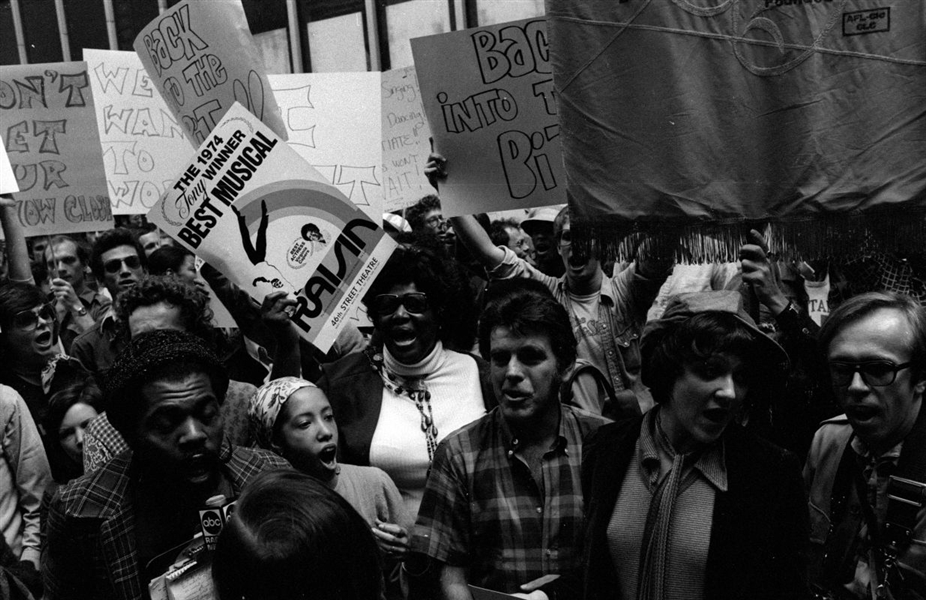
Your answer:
42,442 -> 291,600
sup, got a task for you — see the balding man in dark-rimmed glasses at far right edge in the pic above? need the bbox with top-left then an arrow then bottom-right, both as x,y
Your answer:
804,292 -> 926,600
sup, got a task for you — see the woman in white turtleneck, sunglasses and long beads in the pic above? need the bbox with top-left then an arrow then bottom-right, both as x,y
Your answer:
318,239 -> 495,516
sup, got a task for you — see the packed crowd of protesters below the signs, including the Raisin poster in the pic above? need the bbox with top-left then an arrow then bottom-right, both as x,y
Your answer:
0,2 -> 926,600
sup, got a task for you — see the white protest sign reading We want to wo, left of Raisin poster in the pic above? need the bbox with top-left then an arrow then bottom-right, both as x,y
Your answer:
84,48 -> 195,215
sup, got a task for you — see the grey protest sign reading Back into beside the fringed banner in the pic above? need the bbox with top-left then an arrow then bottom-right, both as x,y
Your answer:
412,19 -> 566,216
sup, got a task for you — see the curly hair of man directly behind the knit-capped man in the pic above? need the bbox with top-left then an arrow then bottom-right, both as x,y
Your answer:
115,275 -> 214,340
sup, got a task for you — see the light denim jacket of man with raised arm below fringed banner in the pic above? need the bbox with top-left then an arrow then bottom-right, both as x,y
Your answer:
489,246 -> 665,412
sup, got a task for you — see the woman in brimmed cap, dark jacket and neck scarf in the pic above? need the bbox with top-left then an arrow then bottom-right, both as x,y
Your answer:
582,292 -> 808,600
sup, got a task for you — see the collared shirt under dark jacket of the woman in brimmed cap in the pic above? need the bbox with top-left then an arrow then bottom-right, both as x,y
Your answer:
607,407 -> 728,600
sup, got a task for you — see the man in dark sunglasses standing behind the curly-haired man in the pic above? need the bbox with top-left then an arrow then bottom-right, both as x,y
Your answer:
71,227 -> 147,376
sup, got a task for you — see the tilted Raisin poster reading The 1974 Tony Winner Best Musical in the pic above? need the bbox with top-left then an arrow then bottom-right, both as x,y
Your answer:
148,104 -> 395,352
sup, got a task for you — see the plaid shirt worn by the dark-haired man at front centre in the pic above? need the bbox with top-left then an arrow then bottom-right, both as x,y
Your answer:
412,406 -> 606,593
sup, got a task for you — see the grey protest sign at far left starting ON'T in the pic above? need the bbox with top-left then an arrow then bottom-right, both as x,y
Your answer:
0,62 -> 113,237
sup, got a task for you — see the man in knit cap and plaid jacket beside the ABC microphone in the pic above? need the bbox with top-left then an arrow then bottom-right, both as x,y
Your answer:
42,329 -> 289,600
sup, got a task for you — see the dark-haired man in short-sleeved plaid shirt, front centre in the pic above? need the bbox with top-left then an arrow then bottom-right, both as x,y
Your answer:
412,279 -> 606,600
